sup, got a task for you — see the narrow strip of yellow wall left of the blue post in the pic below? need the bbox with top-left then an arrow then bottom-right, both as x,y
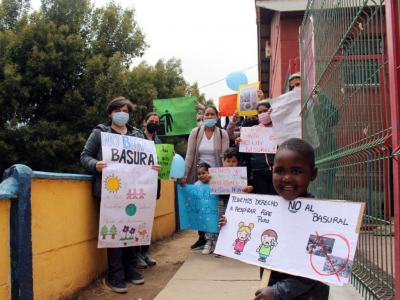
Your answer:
0,199 -> 11,300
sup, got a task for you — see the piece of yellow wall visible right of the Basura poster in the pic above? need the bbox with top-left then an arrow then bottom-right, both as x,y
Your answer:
151,180 -> 175,242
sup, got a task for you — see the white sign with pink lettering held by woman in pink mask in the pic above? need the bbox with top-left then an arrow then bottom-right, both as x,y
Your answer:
239,126 -> 277,153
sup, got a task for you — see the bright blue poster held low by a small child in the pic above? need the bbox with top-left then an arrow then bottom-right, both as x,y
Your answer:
178,184 -> 219,232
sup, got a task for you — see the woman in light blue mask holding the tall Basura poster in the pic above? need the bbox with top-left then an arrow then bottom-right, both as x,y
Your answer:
81,97 -> 161,293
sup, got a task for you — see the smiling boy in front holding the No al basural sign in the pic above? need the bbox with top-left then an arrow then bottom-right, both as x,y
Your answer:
218,138 -> 329,300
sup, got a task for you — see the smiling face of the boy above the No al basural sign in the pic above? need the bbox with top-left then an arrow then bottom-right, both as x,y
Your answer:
273,149 -> 317,200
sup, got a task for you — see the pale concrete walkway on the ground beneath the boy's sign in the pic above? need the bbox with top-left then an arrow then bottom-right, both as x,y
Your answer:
155,251 -> 364,300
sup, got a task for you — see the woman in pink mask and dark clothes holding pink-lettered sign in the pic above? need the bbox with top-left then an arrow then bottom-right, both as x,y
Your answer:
227,100 -> 277,195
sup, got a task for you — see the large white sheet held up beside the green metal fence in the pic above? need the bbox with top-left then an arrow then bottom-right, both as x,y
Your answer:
269,87 -> 302,145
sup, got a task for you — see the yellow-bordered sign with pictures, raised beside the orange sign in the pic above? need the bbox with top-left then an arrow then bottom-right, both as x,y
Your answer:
237,82 -> 260,116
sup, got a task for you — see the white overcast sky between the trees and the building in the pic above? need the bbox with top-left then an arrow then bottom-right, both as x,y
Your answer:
31,0 -> 258,104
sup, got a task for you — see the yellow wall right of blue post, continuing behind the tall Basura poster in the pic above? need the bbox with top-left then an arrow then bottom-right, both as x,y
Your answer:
30,178 -> 175,300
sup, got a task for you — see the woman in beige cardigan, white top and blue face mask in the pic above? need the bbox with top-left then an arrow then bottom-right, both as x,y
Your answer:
179,105 -> 229,250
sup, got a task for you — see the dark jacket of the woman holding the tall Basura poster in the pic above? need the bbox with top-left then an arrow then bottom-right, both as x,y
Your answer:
81,121 -> 160,199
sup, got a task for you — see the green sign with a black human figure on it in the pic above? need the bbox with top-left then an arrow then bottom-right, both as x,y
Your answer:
153,96 -> 197,136
